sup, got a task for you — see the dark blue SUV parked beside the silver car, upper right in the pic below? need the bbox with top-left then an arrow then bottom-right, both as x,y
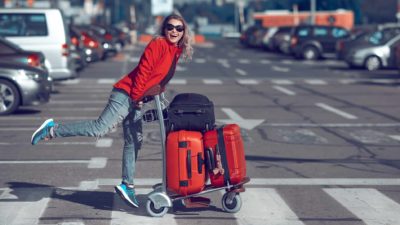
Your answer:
290,25 -> 350,59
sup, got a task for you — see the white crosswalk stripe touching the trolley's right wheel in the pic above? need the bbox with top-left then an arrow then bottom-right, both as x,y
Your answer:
235,188 -> 304,225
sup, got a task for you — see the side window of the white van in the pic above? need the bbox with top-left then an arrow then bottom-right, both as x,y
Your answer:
0,13 -> 48,37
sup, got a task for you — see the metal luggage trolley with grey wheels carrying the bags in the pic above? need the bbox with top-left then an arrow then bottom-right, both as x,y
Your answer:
146,93 -> 250,217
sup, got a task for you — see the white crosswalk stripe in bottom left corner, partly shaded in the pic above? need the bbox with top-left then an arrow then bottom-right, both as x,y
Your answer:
0,188 -> 52,225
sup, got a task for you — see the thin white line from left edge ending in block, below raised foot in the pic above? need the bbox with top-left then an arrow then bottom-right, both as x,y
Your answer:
0,157 -> 107,169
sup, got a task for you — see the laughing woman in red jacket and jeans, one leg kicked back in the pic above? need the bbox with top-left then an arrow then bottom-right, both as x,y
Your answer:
31,14 -> 193,207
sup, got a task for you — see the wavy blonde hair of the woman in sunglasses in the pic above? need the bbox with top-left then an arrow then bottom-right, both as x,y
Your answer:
159,14 -> 193,61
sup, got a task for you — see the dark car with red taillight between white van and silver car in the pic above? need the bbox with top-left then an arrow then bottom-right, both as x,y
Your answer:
0,37 -> 47,70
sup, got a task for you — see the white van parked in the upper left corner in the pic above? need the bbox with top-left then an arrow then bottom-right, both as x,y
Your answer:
0,8 -> 77,80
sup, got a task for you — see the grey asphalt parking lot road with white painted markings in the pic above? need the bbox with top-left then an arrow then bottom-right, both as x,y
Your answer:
0,40 -> 400,225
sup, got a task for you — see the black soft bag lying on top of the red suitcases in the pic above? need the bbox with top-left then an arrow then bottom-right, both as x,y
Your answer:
165,93 -> 215,132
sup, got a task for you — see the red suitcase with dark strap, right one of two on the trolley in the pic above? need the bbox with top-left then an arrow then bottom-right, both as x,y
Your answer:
204,124 -> 246,187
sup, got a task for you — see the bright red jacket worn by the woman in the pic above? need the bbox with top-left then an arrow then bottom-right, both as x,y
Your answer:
114,37 -> 182,102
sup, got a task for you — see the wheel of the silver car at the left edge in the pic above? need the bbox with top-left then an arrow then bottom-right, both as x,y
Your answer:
0,80 -> 20,115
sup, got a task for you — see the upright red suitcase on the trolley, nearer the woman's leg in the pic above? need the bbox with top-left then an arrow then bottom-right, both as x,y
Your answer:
166,130 -> 206,196
